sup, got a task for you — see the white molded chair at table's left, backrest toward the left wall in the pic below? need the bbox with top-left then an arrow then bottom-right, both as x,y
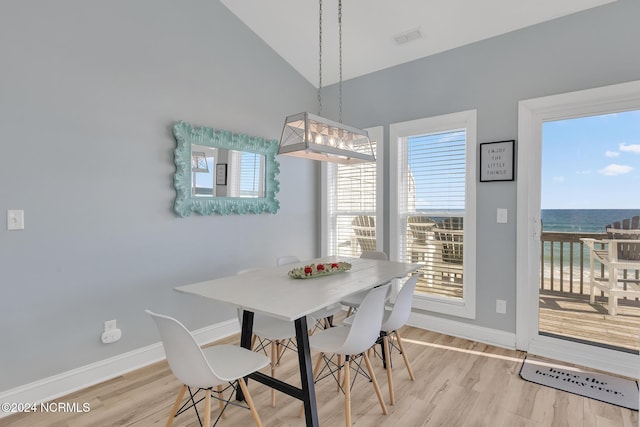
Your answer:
145,310 -> 269,427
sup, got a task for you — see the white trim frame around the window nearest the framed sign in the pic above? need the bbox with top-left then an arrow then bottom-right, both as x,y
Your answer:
389,110 -> 477,319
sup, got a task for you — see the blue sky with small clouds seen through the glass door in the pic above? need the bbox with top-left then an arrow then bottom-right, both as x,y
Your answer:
541,110 -> 640,209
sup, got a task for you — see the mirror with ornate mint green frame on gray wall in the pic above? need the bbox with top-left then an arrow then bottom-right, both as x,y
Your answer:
173,121 -> 280,217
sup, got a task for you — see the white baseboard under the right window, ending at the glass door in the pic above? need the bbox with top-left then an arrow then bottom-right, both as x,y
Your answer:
407,313 -> 516,350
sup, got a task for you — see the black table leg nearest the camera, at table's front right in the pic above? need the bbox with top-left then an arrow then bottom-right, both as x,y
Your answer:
295,316 -> 319,427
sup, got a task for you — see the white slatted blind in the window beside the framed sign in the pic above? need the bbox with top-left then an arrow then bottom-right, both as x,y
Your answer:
399,129 -> 467,298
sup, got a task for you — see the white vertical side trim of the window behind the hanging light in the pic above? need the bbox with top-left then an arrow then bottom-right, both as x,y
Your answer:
320,126 -> 384,256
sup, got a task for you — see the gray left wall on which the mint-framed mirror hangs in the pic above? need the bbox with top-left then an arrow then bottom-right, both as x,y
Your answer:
0,0 -> 317,391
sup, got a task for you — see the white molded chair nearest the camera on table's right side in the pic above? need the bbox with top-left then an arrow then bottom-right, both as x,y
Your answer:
309,285 -> 389,426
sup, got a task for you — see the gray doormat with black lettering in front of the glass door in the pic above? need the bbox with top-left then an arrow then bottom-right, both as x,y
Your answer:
520,356 -> 638,411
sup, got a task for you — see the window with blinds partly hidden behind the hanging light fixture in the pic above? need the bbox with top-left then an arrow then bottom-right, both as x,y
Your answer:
322,127 -> 382,257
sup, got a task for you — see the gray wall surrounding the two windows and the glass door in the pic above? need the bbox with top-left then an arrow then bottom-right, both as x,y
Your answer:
324,0 -> 640,332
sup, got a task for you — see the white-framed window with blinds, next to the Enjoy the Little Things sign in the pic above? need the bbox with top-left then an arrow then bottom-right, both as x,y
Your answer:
390,111 -> 476,318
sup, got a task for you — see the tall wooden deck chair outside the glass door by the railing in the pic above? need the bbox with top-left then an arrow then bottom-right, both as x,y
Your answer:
582,216 -> 640,316
